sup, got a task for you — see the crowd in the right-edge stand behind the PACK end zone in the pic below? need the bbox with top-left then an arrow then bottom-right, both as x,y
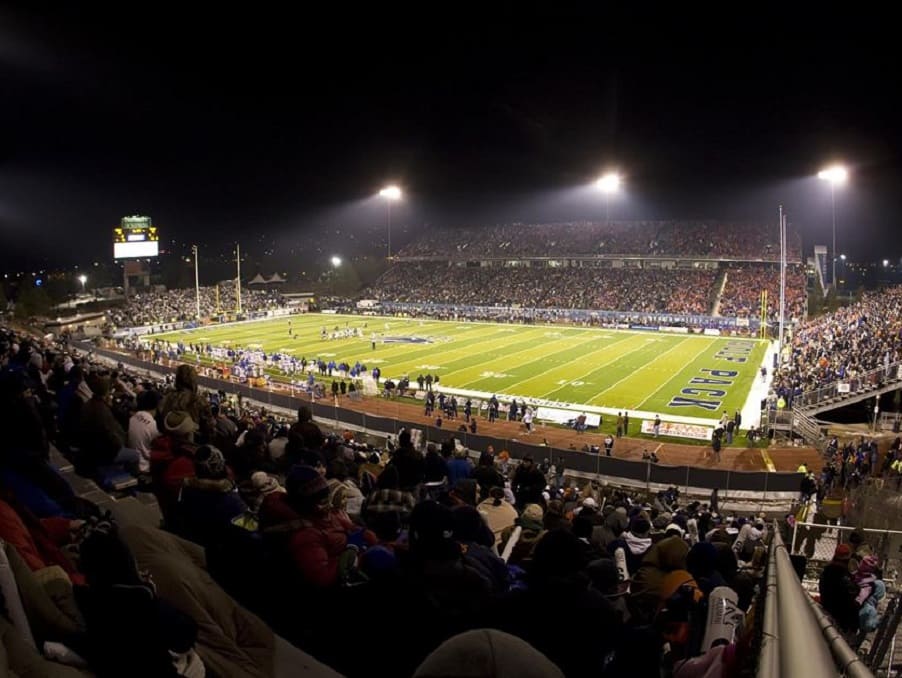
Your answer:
773,286 -> 902,406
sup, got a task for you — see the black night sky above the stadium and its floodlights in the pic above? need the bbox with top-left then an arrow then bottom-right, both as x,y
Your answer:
0,3 -> 902,270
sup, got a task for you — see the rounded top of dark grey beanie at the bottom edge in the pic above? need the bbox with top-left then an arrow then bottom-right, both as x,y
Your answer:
414,629 -> 564,678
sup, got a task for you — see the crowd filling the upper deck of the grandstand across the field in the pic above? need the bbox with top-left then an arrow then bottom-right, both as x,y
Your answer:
398,221 -> 802,262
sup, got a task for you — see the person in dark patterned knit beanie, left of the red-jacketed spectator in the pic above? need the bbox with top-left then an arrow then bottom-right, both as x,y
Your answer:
176,445 -> 248,547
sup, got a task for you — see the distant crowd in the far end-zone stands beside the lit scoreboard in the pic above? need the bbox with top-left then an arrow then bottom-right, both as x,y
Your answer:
108,285 -> 284,328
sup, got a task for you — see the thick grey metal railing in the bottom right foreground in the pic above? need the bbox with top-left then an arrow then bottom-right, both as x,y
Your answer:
757,526 -> 873,678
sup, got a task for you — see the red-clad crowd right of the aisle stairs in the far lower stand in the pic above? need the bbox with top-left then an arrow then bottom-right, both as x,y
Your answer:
718,265 -> 806,323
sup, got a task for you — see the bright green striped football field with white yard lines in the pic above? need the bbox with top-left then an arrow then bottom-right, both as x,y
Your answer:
157,314 -> 765,419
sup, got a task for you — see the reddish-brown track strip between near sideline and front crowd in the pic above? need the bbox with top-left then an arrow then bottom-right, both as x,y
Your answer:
328,397 -> 823,471
